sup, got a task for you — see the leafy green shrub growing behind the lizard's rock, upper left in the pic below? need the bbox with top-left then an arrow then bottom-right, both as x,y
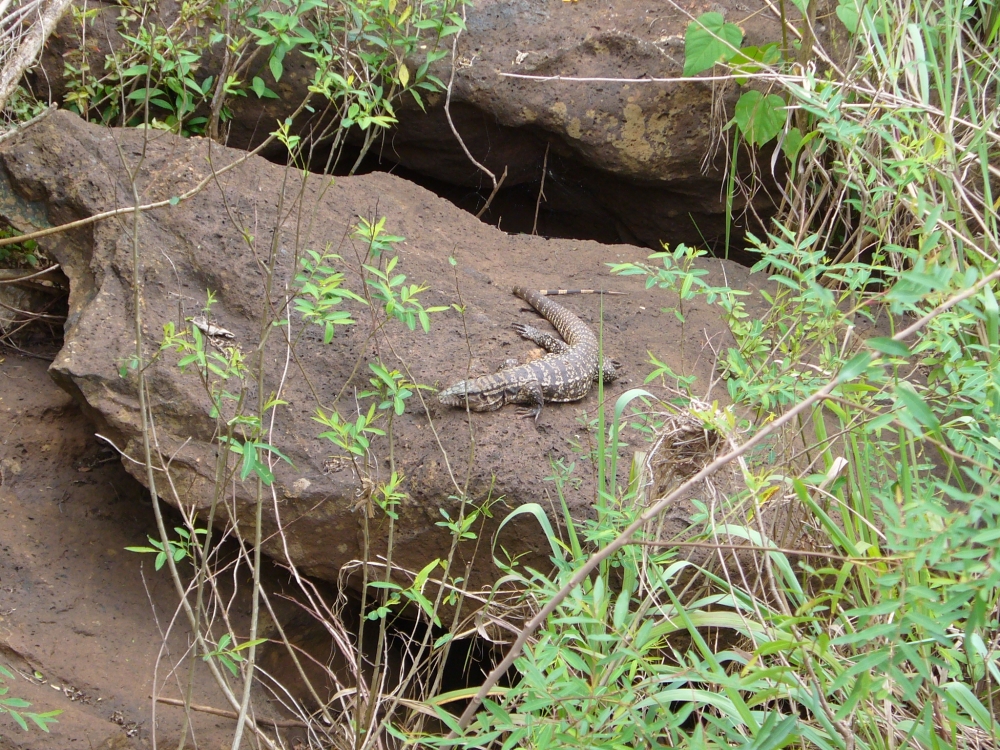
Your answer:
65,0 -> 464,150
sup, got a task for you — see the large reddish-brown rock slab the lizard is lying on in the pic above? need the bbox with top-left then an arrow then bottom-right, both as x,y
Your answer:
0,112 -> 764,585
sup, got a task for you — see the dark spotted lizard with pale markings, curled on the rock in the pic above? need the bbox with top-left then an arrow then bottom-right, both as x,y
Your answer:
438,286 -> 618,421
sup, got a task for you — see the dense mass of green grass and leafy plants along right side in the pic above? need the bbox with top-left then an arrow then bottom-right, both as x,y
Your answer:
400,0 -> 1000,750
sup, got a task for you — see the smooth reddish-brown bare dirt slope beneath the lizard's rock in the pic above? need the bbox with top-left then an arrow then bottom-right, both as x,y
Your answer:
0,354 -> 282,750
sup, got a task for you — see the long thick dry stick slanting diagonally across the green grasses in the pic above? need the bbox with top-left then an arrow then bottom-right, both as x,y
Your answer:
448,269 -> 1000,738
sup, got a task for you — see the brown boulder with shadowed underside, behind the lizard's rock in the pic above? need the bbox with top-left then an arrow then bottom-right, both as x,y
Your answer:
36,0 -> 782,249
